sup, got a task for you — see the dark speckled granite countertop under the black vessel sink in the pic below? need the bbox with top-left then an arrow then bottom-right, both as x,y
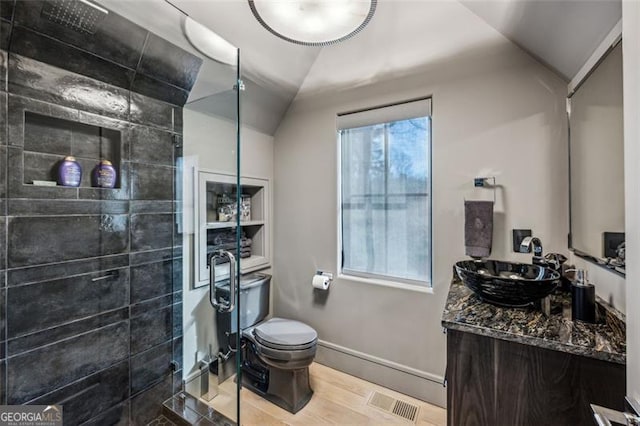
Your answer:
442,276 -> 626,364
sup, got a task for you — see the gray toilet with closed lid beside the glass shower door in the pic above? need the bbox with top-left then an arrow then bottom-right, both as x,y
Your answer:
217,273 -> 318,414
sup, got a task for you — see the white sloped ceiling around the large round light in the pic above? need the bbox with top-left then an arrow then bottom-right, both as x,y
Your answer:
98,0 -> 621,134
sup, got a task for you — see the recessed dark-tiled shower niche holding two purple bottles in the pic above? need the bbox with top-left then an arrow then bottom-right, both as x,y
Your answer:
22,111 -> 122,191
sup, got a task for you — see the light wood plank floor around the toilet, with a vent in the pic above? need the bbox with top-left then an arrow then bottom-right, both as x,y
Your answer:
210,363 -> 447,426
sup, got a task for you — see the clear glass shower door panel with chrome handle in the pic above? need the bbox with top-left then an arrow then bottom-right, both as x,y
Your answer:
178,40 -> 243,422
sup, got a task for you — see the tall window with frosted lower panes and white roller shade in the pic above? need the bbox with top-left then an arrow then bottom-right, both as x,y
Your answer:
338,99 -> 431,286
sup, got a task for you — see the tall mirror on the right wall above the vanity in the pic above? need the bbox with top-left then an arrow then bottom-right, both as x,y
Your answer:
569,42 -> 625,274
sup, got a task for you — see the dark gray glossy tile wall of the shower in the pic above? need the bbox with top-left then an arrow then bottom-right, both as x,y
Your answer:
0,0 -> 199,425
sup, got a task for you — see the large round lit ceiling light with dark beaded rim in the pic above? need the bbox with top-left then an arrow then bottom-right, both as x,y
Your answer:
248,0 -> 377,46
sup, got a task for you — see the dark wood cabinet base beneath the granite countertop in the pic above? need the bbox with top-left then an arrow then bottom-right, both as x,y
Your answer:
446,330 -> 625,426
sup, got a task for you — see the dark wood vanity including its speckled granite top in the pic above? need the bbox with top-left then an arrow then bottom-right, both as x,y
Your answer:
442,279 -> 626,426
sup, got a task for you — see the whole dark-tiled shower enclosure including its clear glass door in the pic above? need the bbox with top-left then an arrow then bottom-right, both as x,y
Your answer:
0,0 -> 245,425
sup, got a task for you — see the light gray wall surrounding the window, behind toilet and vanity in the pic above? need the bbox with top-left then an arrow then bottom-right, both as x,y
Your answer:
273,37 -> 568,405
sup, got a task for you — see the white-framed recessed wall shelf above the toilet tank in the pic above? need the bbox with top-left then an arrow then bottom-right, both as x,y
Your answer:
194,170 -> 271,288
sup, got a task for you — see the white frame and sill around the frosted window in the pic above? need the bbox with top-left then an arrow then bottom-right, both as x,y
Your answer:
336,97 -> 433,293
